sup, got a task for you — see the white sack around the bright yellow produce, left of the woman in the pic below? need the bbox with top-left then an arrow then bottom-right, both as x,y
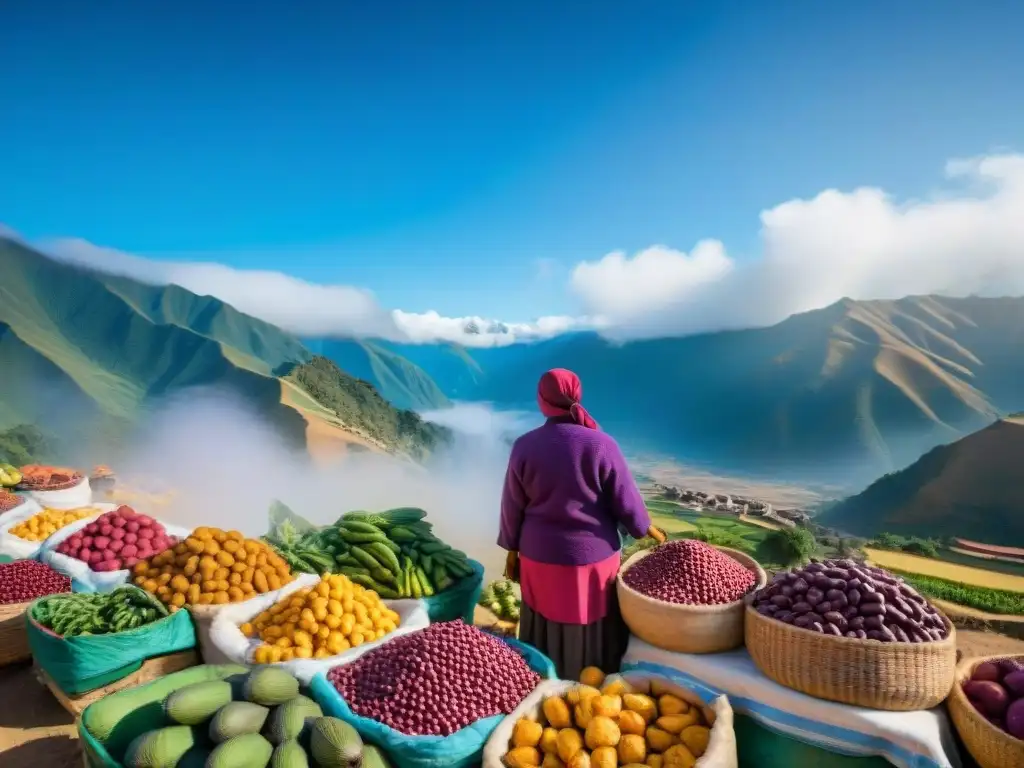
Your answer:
199,573 -> 430,685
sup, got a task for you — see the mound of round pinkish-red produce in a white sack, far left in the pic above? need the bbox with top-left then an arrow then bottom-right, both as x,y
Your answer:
55,506 -> 177,571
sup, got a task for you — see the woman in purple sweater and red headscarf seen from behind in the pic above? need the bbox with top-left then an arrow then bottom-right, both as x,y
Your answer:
498,369 -> 665,680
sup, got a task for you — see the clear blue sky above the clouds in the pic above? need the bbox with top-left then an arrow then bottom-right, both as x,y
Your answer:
0,0 -> 1024,335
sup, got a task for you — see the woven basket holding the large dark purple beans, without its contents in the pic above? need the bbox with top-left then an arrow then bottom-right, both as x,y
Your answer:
746,604 -> 956,712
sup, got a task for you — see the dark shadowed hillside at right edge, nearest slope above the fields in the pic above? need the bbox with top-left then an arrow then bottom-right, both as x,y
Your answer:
816,417 -> 1024,545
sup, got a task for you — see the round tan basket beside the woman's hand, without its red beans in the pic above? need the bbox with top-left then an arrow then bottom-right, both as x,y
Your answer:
616,547 -> 768,653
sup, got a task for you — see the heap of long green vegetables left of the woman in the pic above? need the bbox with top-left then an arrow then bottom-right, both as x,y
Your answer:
266,507 -> 473,599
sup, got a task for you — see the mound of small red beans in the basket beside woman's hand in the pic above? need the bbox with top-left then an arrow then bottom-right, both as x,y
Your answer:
623,539 -> 757,605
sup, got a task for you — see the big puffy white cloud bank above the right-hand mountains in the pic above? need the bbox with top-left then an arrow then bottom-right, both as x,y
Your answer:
570,155 -> 1024,340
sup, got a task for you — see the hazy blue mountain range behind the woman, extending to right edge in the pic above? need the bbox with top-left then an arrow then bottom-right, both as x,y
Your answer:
321,296 -> 1024,486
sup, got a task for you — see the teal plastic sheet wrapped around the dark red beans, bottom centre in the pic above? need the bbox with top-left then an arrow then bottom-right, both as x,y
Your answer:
311,638 -> 556,768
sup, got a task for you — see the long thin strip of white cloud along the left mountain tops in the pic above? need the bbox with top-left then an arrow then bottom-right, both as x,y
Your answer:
22,228 -> 585,347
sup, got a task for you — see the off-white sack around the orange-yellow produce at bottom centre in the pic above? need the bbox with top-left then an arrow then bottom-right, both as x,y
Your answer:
483,672 -> 739,768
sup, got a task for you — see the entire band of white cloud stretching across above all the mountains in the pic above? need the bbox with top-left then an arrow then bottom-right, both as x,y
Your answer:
8,155 -> 1024,346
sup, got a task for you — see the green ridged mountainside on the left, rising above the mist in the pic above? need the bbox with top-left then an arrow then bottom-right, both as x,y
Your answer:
0,239 -> 448,460
